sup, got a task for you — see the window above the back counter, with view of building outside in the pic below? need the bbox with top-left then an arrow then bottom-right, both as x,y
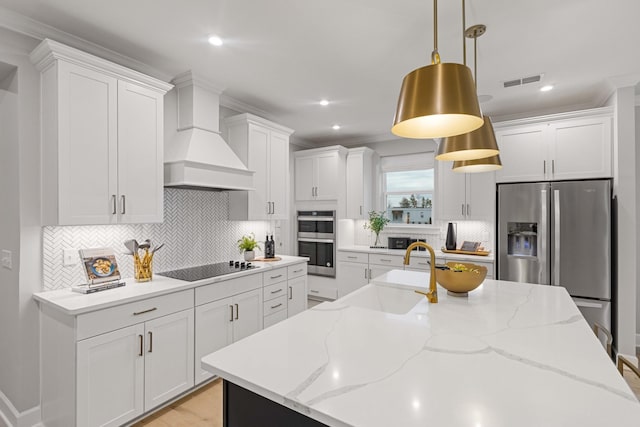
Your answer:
382,153 -> 434,224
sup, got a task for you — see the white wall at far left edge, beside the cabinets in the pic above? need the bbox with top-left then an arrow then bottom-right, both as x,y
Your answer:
0,30 -> 42,425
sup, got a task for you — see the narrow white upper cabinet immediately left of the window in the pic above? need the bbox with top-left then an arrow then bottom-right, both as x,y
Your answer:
346,148 -> 378,219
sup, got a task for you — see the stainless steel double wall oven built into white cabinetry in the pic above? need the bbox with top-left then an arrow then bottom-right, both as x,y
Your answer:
297,211 -> 336,277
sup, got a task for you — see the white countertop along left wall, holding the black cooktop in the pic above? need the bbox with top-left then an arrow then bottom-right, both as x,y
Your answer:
33,255 -> 308,316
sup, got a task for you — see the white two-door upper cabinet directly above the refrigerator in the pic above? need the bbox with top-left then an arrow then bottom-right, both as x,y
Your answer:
496,108 -> 612,182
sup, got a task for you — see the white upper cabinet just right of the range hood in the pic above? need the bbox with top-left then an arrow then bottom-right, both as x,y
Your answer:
225,114 -> 293,220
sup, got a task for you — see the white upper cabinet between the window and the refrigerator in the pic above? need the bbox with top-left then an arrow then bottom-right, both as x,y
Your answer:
436,162 -> 496,221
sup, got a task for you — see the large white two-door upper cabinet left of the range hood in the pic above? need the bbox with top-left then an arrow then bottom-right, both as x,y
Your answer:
31,40 -> 172,225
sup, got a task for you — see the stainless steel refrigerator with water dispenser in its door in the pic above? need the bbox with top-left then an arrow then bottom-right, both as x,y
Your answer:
497,180 -> 612,331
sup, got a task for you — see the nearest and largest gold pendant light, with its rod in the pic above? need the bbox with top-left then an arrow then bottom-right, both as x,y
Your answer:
391,0 -> 483,138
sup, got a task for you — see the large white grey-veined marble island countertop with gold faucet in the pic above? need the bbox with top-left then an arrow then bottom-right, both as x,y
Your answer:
202,270 -> 640,427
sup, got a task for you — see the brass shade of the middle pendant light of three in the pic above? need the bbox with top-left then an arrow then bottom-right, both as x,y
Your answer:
436,116 -> 500,161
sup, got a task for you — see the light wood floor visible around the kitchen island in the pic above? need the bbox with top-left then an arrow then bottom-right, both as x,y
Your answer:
133,369 -> 640,427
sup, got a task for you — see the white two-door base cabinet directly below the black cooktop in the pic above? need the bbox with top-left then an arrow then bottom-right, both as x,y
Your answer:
195,274 -> 263,384
